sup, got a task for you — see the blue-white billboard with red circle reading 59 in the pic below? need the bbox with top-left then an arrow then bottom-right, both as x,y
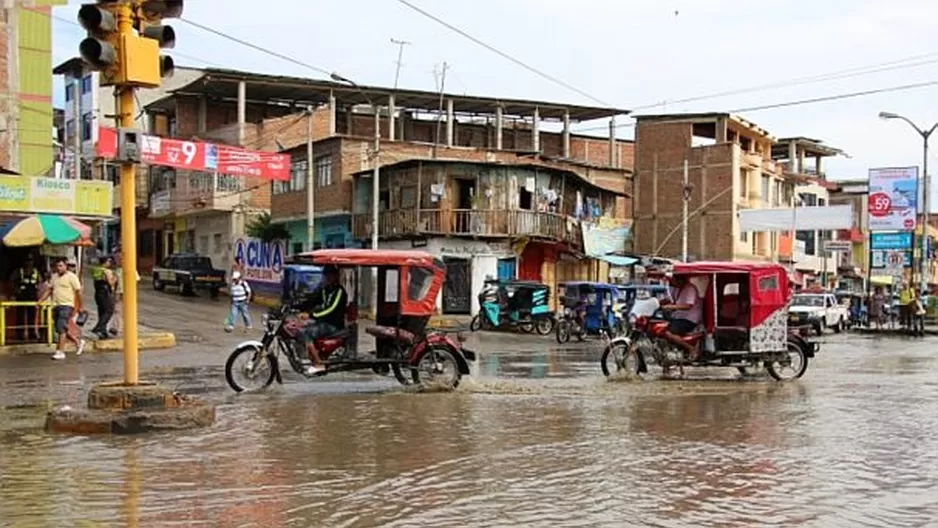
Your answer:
867,167 -> 918,231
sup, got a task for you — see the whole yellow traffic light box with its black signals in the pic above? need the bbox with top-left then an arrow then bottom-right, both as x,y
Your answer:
78,0 -> 183,88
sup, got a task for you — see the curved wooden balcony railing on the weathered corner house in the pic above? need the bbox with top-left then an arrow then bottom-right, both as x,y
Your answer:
352,209 -> 583,248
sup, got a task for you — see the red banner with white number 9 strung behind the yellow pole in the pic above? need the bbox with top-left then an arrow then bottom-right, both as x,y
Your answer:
97,127 -> 290,181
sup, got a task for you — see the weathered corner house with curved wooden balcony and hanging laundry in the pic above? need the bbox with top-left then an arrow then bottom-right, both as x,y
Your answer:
352,159 -> 629,314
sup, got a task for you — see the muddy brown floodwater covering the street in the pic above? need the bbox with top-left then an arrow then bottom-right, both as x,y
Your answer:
0,336 -> 938,527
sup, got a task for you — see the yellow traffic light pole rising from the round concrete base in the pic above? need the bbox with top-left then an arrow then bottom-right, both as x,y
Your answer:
116,3 -> 140,385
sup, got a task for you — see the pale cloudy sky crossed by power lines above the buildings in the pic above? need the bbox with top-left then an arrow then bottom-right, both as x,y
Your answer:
45,0 -> 938,209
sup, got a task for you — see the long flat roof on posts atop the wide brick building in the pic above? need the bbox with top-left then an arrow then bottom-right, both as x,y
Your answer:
147,68 -> 629,122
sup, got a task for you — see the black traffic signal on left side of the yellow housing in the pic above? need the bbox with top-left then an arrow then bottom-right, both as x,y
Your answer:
78,0 -> 120,86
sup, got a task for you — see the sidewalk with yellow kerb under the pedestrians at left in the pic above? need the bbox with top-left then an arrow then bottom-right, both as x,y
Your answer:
0,274 -> 176,356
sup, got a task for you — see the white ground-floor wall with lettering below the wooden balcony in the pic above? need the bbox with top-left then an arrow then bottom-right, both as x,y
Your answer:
380,238 -> 514,313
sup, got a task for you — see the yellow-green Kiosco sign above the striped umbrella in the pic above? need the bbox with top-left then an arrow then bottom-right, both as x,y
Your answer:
0,176 -> 114,217
